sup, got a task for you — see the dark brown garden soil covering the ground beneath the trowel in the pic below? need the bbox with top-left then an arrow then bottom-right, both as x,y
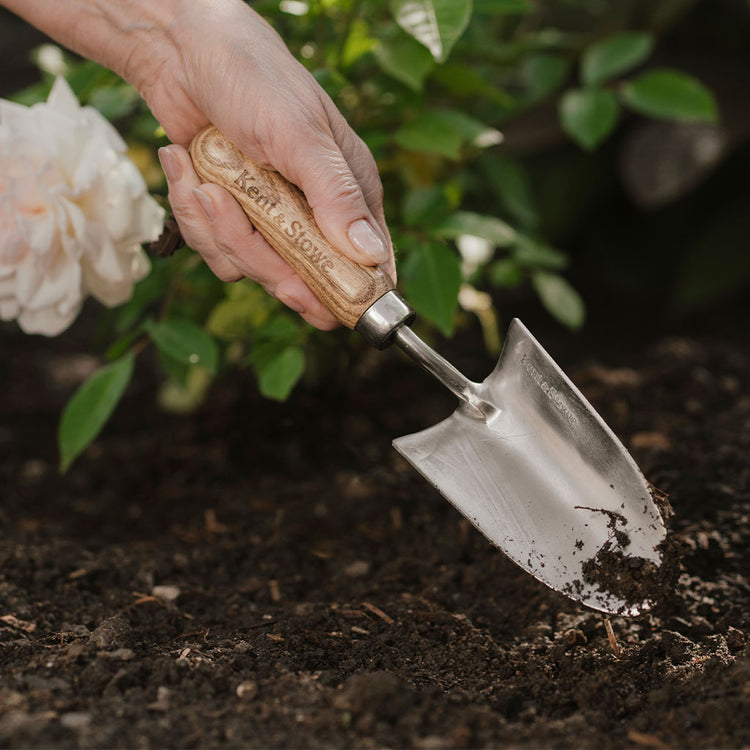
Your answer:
0,306 -> 750,749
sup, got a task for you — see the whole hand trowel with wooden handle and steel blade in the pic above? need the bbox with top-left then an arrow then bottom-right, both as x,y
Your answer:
190,126 -> 666,615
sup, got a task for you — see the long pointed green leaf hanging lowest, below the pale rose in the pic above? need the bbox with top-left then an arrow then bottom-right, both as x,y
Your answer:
57,352 -> 135,472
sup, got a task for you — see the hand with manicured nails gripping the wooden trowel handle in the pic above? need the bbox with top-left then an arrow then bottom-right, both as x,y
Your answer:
140,0 -> 395,329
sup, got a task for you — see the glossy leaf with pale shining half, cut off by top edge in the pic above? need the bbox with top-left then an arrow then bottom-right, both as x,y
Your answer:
391,0 -> 471,62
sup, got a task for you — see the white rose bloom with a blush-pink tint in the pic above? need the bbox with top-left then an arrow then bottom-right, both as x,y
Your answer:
0,78 -> 164,336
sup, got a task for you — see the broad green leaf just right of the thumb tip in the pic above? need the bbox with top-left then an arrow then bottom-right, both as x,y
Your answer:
403,241 -> 461,336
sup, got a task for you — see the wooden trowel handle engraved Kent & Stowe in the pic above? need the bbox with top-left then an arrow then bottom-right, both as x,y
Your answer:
190,126 -> 393,328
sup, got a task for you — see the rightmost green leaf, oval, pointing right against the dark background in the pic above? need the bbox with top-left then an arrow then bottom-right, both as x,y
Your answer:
620,68 -> 718,122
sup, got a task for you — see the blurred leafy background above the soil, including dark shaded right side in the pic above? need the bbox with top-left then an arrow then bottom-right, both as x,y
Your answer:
3,0 -> 750,470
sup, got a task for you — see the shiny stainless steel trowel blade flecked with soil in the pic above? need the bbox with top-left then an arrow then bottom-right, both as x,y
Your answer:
393,320 -> 666,614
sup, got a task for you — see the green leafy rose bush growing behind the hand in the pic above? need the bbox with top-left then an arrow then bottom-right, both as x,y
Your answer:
11,0 -> 716,468
